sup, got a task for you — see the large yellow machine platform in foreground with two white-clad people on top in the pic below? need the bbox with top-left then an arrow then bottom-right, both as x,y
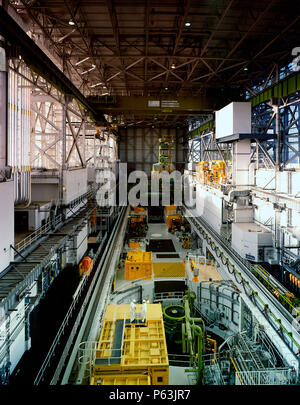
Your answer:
90,303 -> 169,385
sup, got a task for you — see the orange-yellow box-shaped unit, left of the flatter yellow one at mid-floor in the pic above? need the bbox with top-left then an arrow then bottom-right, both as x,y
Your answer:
125,252 -> 152,280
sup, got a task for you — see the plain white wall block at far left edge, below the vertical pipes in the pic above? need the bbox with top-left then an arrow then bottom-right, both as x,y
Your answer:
0,181 -> 15,273
